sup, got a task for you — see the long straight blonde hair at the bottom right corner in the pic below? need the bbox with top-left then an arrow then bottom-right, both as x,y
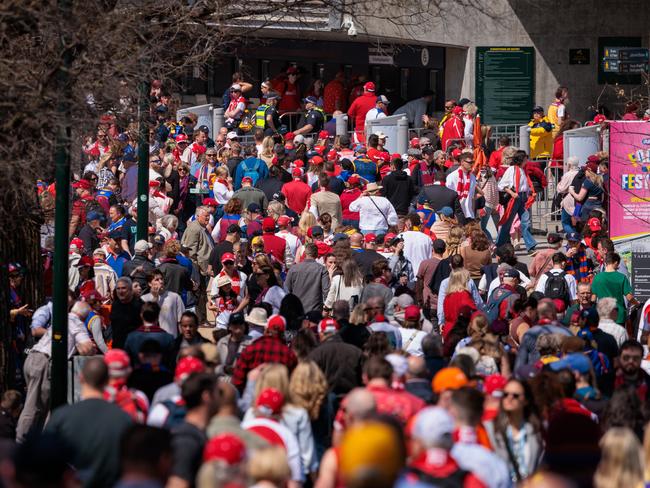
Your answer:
594,427 -> 643,488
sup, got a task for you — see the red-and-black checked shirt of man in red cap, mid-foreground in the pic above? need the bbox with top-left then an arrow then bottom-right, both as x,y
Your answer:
232,335 -> 298,391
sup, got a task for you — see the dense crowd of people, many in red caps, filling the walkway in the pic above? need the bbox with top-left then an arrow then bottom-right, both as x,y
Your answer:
0,73 -> 650,488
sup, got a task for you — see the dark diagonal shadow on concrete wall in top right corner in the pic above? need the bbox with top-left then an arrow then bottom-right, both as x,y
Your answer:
507,0 -> 650,121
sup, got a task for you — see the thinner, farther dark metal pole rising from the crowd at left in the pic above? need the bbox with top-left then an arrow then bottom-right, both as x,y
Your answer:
137,81 -> 149,241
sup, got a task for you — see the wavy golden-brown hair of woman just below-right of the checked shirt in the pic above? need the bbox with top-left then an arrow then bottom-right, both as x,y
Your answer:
289,361 -> 328,420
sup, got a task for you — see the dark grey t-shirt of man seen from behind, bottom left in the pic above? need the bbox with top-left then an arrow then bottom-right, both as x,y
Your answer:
45,398 -> 132,488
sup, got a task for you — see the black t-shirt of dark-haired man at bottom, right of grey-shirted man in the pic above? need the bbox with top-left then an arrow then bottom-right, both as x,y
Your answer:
171,422 -> 207,486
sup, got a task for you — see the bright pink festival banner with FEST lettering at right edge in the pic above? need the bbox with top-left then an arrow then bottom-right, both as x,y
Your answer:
609,121 -> 650,241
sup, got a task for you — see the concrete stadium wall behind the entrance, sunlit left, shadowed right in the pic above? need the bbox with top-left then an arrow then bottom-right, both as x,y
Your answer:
360,0 -> 650,120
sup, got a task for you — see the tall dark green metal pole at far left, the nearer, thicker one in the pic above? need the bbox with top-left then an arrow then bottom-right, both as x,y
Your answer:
50,0 -> 72,409
